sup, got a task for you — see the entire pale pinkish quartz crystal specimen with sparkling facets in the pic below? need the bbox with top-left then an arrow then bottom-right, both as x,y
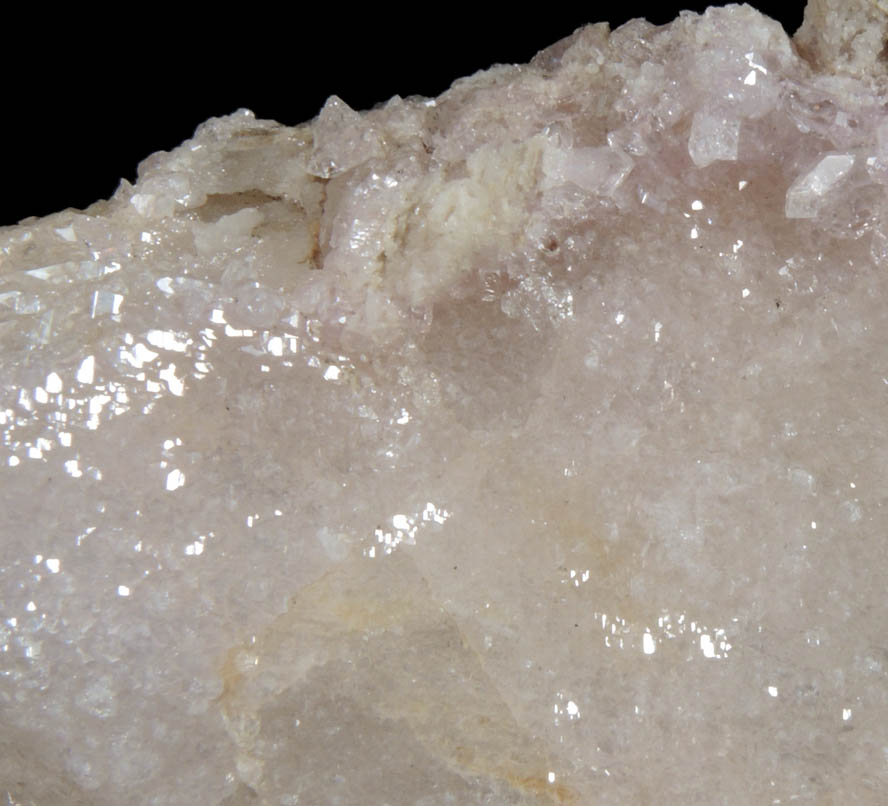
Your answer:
0,0 -> 888,806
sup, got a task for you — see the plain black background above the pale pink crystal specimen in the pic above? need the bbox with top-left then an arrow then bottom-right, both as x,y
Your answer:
0,0 -> 804,225
